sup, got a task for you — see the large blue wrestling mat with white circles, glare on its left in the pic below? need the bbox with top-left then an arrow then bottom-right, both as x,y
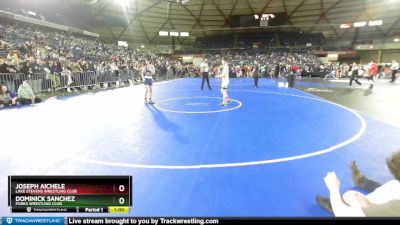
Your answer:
0,78 -> 400,217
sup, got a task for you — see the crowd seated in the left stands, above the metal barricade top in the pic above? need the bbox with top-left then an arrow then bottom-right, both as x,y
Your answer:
0,18 -> 180,73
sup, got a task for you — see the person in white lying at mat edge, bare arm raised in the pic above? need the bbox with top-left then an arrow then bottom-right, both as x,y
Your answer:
317,151 -> 400,217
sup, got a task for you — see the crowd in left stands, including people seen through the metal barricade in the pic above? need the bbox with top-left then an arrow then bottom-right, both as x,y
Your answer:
0,20 -> 190,102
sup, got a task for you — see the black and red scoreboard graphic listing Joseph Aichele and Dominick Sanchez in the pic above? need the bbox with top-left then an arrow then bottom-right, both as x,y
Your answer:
8,176 -> 132,213
